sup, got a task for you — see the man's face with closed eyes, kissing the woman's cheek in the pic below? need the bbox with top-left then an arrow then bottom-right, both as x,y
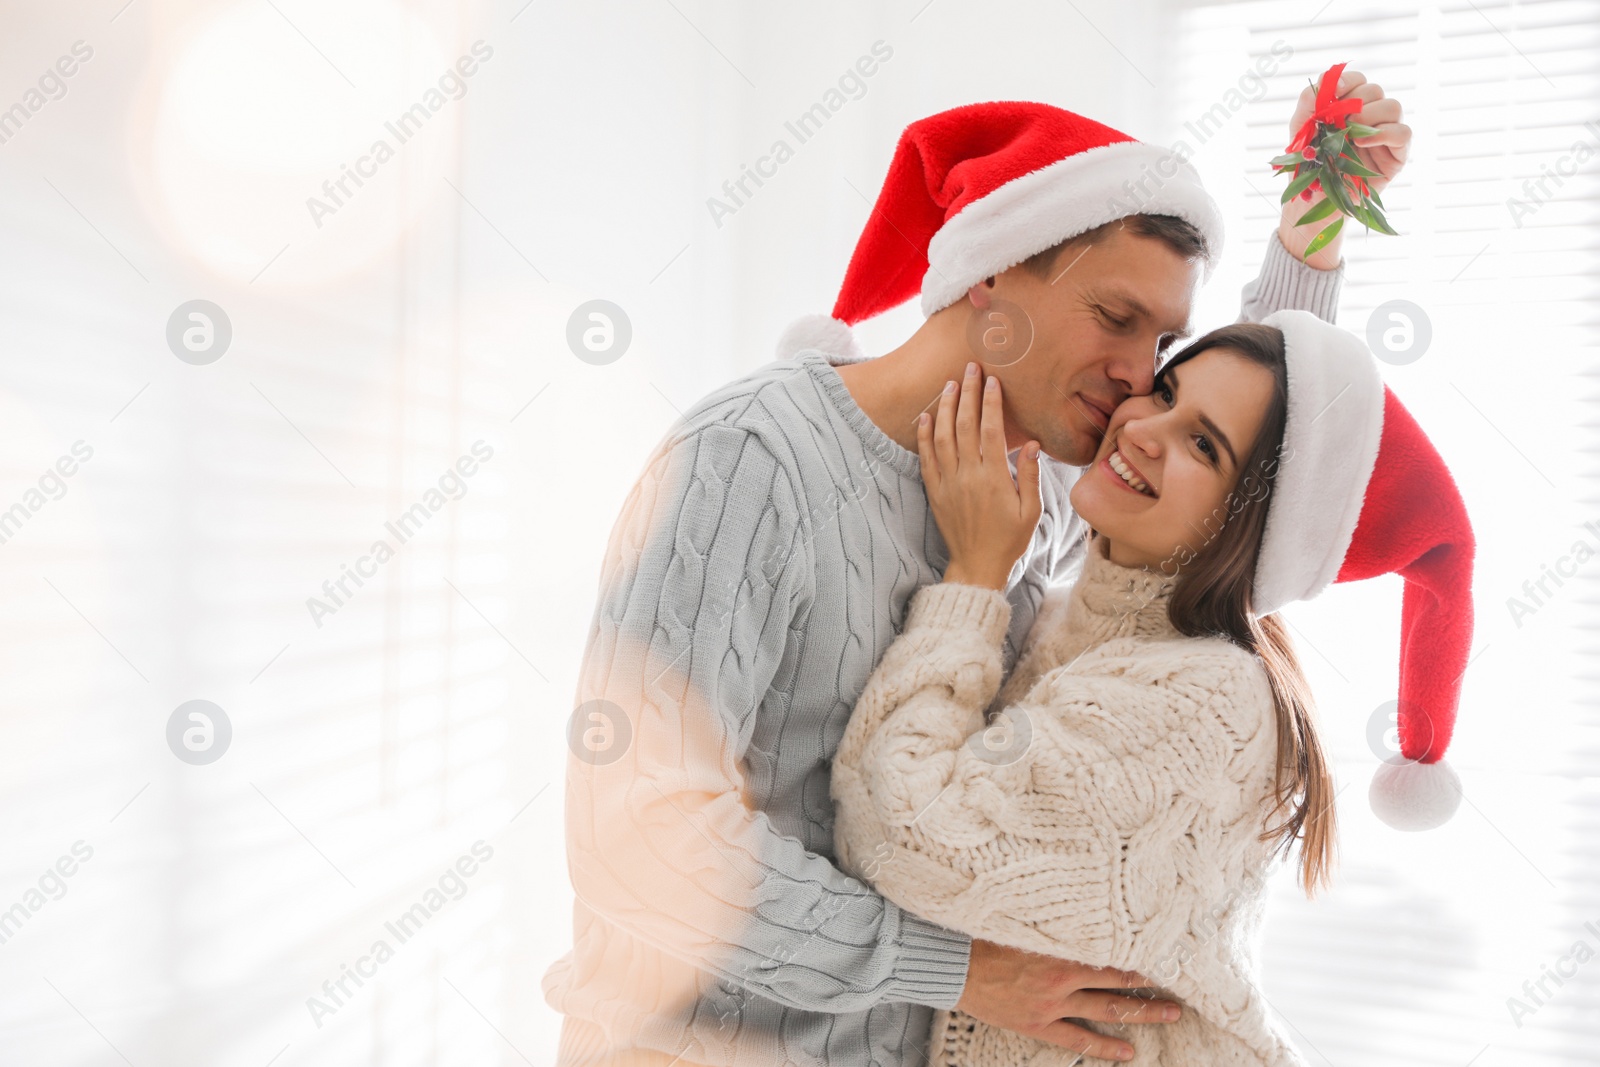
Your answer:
965,227 -> 1203,467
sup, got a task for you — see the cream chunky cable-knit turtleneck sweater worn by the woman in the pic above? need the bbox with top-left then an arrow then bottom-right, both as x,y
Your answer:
832,541 -> 1306,1067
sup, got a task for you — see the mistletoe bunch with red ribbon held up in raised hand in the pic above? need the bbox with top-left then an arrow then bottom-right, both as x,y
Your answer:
1272,62 -> 1397,259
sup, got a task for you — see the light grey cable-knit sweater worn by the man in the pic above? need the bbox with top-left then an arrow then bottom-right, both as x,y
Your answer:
544,238 -> 1342,1067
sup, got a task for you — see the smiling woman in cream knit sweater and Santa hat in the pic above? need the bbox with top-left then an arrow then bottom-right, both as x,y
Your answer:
834,312 -> 1472,1067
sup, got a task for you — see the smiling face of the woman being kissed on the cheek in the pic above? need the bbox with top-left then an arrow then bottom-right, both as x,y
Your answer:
1072,347 -> 1274,574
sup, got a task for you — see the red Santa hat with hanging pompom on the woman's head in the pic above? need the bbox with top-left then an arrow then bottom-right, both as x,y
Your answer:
1253,310 -> 1474,830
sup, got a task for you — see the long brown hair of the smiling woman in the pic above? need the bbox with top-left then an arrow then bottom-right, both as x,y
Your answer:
1157,323 -> 1336,896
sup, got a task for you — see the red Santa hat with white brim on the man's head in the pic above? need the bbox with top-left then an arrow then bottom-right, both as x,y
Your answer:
778,101 -> 1222,357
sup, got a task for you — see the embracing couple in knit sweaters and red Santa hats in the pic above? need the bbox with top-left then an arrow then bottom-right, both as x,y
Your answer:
544,72 -> 1472,1067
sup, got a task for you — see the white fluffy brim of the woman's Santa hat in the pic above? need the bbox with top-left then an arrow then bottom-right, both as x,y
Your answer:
1254,310 -> 1384,616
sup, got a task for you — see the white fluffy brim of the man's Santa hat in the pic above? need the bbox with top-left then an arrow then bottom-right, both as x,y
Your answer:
922,141 -> 1222,315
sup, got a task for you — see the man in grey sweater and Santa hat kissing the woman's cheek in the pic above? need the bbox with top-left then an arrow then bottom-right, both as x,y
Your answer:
544,72 -> 1410,1067
